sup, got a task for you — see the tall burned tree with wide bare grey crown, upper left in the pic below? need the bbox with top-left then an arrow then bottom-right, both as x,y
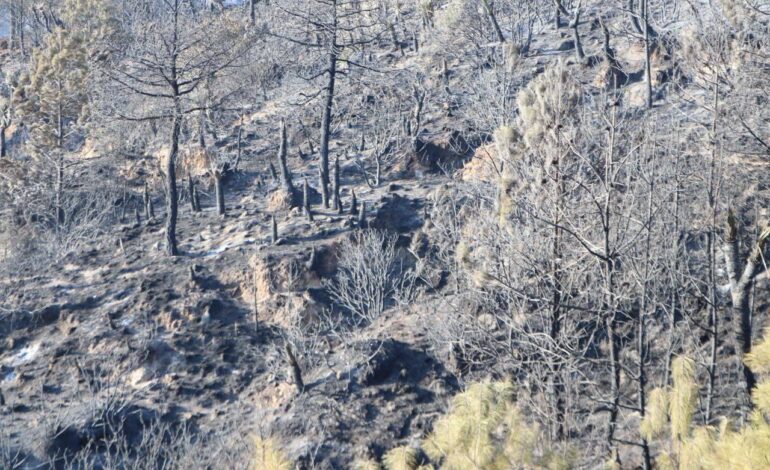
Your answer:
107,0 -> 248,256
